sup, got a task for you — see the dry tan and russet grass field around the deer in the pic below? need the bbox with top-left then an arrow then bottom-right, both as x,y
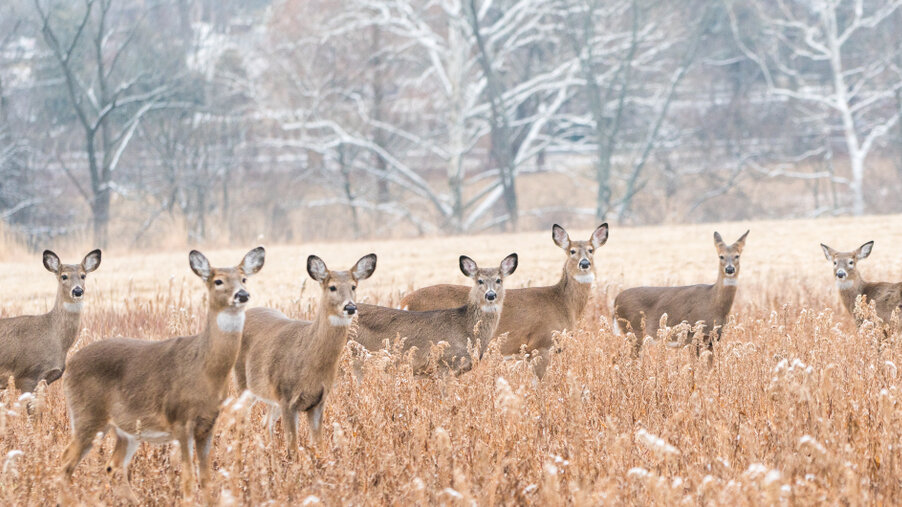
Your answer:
0,216 -> 902,505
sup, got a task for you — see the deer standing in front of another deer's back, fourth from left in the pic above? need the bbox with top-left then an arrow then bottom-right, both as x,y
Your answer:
356,254 -> 517,373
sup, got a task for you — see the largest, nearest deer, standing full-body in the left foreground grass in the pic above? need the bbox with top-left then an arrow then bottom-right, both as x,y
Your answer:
62,247 -> 265,501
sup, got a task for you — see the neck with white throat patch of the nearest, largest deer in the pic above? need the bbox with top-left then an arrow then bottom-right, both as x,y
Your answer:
199,307 -> 244,381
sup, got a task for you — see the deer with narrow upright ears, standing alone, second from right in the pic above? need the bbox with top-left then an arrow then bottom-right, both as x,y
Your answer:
614,231 -> 749,355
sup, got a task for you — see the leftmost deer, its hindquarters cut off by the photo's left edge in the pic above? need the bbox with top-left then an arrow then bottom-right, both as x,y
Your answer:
0,250 -> 100,392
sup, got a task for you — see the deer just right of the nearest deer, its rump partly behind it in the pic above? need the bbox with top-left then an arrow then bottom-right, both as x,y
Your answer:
235,254 -> 376,456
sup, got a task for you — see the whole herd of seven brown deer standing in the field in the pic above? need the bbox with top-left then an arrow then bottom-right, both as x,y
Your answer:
0,224 -> 902,501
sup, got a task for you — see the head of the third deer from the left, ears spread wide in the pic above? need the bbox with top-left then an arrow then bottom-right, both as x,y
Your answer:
307,254 -> 376,326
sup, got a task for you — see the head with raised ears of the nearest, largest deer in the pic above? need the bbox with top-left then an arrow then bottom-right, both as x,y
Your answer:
188,247 -> 266,318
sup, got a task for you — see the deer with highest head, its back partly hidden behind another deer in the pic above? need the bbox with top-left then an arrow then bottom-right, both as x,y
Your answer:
401,223 -> 608,378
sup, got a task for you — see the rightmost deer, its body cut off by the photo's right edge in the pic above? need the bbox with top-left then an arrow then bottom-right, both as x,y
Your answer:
821,241 -> 902,332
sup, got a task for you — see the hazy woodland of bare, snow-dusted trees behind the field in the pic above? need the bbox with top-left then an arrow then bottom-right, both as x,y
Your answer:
0,0 -> 902,248
